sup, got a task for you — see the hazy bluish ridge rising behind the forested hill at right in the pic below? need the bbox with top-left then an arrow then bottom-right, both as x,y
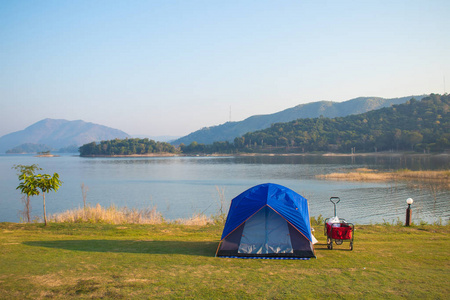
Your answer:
171,95 -> 425,145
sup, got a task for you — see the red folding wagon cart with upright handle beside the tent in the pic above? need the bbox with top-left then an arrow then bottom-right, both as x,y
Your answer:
324,197 -> 355,250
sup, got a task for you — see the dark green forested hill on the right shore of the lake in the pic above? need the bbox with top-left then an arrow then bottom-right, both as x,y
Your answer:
181,94 -> 450,153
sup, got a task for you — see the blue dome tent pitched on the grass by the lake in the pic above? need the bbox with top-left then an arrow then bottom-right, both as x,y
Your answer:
216,183 -> 315,259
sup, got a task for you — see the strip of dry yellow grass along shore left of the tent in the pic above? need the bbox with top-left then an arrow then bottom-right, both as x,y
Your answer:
50,204 -> 214,226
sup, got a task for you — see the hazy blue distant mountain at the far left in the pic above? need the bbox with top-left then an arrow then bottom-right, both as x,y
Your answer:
0,119 -> 130,153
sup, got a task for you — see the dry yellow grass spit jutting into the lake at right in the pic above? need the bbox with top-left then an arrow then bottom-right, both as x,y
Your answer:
317,168 -> 450,188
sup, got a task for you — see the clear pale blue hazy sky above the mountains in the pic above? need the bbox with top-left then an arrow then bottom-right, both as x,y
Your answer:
0,0 -> 450,136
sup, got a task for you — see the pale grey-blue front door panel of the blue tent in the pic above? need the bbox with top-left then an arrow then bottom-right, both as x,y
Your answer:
238,206 -> 294,254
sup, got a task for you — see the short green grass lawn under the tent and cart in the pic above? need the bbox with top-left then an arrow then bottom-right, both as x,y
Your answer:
0,223 -> 450,299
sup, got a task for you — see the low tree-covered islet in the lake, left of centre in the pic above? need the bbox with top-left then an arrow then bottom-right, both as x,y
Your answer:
79,138 -> 177,156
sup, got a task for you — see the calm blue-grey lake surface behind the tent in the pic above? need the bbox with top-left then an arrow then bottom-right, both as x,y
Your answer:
0,155 -> 450,224
